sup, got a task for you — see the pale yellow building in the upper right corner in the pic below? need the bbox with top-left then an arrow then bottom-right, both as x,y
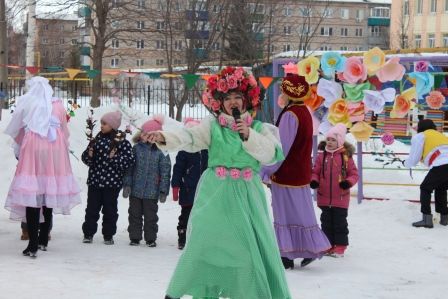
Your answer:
390,0 -> 448,49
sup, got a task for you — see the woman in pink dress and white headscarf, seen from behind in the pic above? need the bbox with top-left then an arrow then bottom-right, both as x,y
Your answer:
5,77 -> 81,257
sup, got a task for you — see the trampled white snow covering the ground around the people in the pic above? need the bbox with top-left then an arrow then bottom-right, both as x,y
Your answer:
0,106 -> 448,299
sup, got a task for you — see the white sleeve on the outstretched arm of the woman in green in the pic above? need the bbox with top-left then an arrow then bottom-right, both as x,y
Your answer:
157,116 -> 214,153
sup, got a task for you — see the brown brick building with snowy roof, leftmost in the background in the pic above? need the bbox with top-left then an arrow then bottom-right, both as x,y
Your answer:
35,14 -> 80,67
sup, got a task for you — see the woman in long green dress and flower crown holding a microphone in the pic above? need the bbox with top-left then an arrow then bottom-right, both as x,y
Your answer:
150,67 -> 292,299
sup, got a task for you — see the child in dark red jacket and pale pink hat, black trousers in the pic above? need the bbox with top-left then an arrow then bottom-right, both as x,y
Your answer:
310,124 -> 358,257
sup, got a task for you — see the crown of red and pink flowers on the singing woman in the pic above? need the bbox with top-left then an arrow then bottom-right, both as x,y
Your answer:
202,66 -> 261,113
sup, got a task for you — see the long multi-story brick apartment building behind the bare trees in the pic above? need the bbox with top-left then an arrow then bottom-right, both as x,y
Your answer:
89,0 -> 391,69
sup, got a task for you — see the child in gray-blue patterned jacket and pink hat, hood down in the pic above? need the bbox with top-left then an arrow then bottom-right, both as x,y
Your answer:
123,119 -> 171,247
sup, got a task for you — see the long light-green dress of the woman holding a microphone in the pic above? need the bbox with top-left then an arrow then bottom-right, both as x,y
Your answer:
167,121 -> 291,299
